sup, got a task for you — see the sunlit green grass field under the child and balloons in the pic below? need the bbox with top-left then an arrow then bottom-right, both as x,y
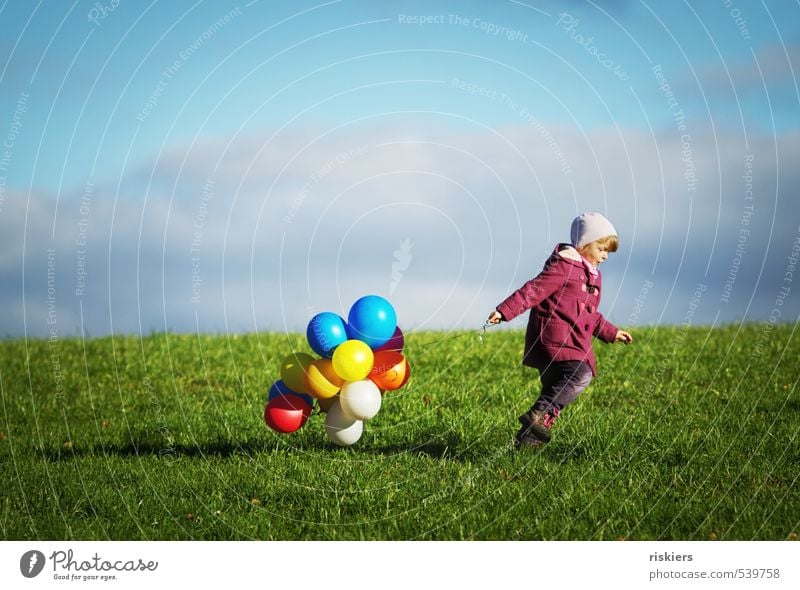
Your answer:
0,325 -> 800,540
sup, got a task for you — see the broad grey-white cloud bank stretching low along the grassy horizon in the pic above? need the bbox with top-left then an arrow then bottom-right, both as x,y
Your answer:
0,124 -> 800,335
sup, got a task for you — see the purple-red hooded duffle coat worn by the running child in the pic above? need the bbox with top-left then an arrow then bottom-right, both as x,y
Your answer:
497,244 -> 617,375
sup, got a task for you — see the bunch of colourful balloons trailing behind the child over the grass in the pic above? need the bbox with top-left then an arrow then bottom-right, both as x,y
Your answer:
264,295 -> 411,446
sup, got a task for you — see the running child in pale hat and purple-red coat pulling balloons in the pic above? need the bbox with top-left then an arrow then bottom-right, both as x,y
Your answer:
487,213 -> 633,448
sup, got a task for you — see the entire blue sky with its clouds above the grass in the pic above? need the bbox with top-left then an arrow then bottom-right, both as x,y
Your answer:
0,0 -> 800,337
